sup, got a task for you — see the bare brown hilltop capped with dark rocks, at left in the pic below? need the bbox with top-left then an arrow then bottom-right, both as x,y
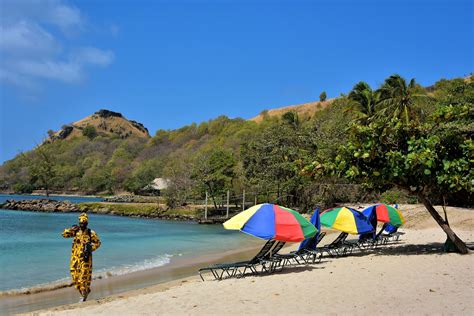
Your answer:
48,109 -> 150,141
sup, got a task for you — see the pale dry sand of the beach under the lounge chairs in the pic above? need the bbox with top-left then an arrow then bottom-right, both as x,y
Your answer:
23,206 -> 474,315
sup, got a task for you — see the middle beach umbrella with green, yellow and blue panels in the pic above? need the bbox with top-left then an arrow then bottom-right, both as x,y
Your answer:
321,207 -> 375,235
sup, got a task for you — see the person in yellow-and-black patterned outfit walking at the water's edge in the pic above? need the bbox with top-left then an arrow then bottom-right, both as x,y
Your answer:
62,213 -> 100,302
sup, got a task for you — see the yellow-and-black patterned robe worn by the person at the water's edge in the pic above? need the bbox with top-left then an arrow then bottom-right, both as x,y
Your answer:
62,228 -> 100,296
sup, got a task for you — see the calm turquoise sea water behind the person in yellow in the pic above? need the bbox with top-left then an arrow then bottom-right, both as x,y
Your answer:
0,196 -> 254,292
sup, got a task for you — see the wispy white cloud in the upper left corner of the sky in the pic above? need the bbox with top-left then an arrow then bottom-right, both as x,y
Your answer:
0,0 -> 114,91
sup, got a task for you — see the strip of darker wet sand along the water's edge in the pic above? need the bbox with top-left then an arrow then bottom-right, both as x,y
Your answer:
0,242 -> 261,315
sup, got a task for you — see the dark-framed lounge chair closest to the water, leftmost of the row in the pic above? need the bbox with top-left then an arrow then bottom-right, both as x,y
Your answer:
198,239 -> 276,281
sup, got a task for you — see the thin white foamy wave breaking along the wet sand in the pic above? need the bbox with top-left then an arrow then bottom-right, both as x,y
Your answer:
0,254 -> 174,297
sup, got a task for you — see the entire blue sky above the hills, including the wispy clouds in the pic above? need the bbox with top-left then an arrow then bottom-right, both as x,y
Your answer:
0,0 -> 474,162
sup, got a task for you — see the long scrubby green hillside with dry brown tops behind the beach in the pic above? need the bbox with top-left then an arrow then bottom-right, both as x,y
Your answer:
0,77 -> 474,210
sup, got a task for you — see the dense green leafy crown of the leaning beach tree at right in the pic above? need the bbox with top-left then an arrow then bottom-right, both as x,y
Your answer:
309,77 -> 474,205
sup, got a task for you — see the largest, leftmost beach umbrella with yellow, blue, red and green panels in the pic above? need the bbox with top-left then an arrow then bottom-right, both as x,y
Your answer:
224,203 -> 317,242
